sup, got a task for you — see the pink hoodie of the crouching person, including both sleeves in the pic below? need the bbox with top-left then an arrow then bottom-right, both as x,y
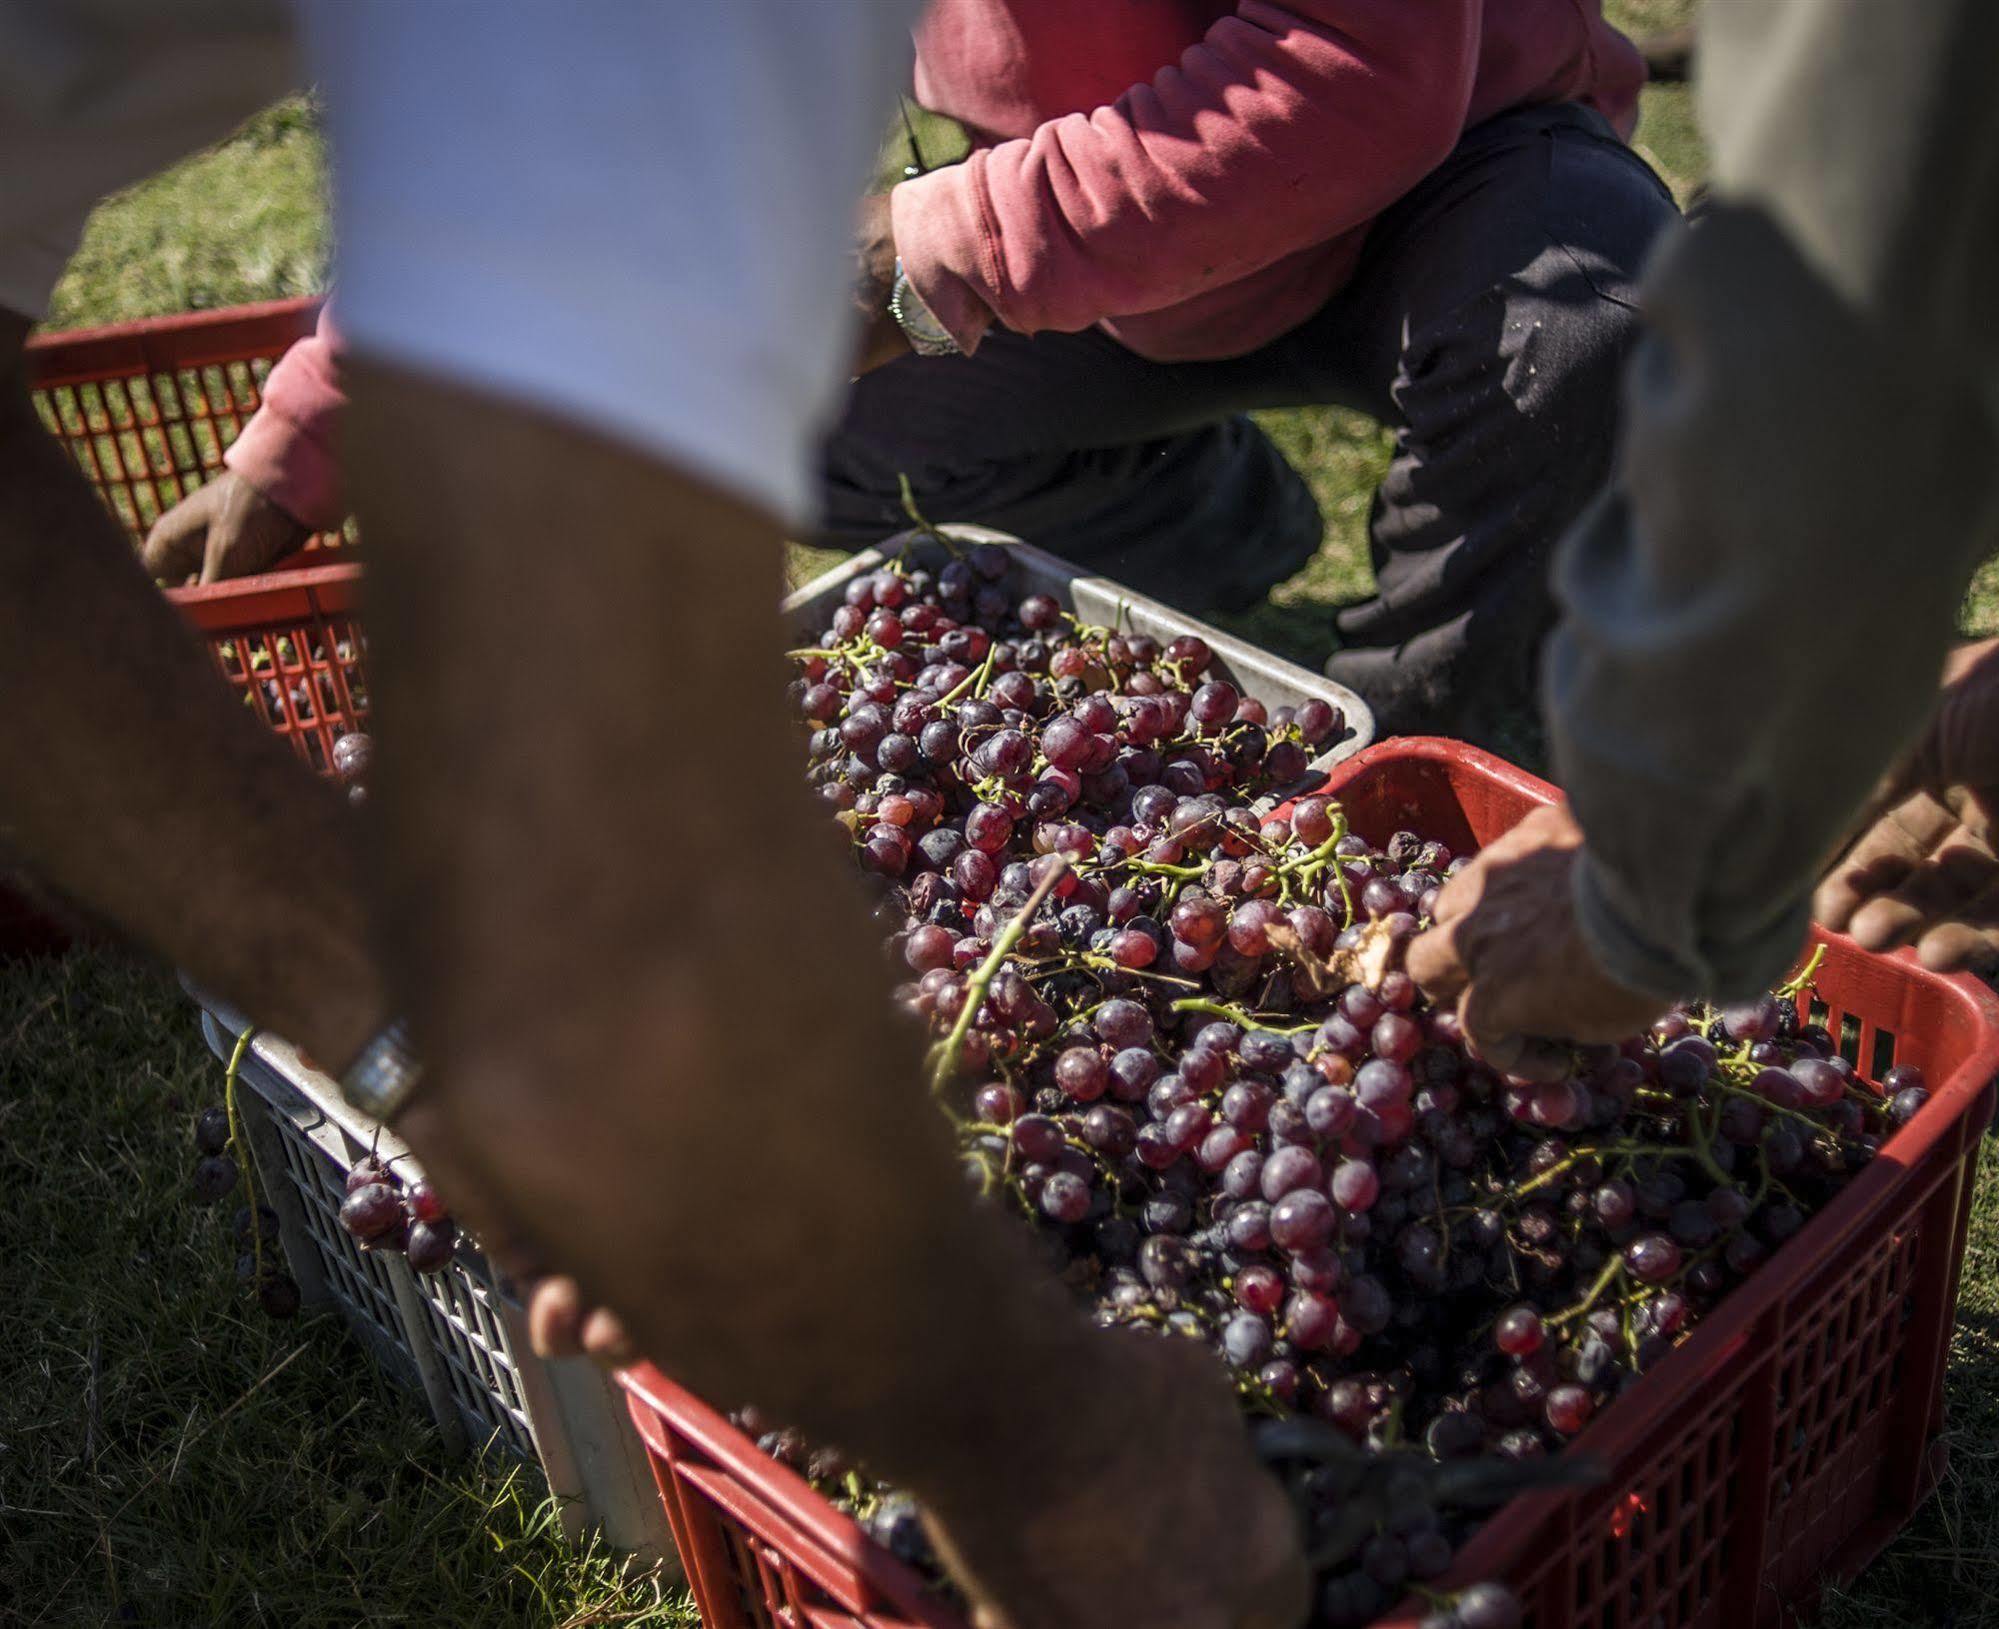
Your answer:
228,0 -> 1645,526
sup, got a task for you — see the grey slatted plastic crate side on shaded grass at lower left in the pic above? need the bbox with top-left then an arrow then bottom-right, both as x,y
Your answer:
196,993 -> 674,1561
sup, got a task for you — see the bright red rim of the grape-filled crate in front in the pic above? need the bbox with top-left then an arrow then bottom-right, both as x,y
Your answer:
618,736 -> 1999,1629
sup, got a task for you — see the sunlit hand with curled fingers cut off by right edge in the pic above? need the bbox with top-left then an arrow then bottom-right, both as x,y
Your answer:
1813,640 -> 1999,971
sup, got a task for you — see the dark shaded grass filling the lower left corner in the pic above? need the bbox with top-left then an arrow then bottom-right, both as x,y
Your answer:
0,953 -> 696,1629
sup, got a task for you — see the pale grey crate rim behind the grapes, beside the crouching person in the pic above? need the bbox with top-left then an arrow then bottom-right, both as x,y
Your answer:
784,526 -> 1375,780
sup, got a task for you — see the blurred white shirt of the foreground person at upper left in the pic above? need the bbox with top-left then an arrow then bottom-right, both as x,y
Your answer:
0,0 -> 916,520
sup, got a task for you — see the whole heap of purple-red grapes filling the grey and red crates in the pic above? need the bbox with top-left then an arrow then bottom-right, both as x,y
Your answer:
756,548 -> 1925,1629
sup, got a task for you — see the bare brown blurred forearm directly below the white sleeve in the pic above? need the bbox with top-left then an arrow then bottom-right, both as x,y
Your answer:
354,366 -> 1135,1499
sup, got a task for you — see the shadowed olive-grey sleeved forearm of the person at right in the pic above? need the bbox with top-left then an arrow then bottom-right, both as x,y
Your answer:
1547,210 -> 1995,995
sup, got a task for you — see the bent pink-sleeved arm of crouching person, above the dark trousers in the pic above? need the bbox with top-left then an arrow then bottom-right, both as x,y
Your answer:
890,0 -> 1481,350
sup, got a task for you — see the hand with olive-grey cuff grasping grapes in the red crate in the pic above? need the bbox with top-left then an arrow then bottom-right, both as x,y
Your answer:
1407,804 -> 1665,1079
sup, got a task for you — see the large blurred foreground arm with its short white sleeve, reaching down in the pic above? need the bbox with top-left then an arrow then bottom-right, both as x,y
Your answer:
299,0 -> 1301,1629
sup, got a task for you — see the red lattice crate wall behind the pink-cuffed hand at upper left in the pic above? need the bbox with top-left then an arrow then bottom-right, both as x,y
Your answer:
28,300 -> 344,564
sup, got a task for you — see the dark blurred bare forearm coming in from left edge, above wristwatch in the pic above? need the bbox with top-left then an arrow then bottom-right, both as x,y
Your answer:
0,316 -> 382,1061
